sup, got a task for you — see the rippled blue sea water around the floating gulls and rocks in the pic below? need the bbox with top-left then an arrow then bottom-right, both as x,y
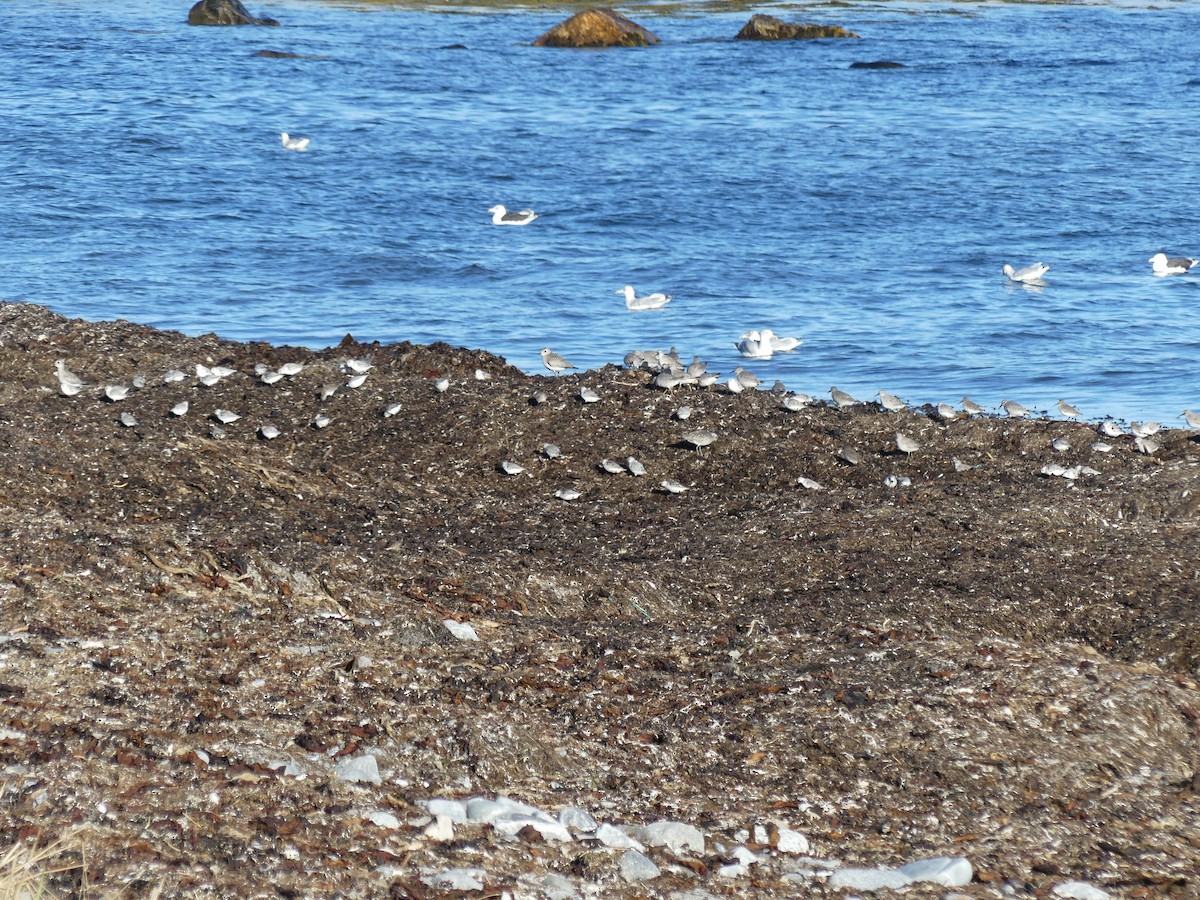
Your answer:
0,0 -> 1200,424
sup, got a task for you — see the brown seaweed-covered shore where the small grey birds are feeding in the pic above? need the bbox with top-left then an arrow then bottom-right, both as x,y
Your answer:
0,304 -> 1200,898
